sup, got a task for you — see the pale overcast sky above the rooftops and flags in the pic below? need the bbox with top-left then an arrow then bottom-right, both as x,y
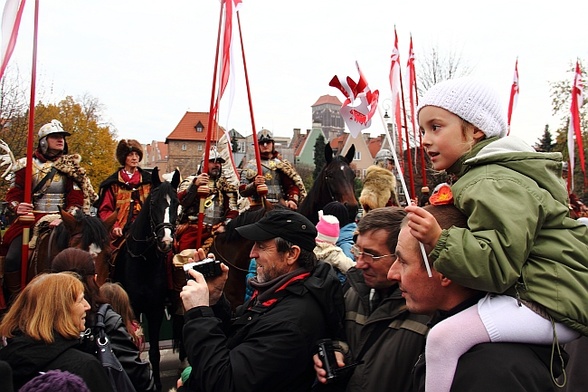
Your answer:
5,0 -> 588,144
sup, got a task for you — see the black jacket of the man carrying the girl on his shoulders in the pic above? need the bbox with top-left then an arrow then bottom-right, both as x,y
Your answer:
414,297 -> 567,392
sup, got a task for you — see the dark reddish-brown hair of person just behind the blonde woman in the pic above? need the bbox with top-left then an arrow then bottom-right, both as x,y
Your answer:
51,248 -> 108,318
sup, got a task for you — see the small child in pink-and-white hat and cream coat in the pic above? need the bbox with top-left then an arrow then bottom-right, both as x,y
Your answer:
314,210 -> 355,283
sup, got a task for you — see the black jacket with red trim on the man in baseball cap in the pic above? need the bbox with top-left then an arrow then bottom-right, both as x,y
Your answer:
181,262 -> 343,392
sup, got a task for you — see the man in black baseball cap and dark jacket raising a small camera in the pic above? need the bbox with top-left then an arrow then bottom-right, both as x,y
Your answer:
180,208 -> 343,392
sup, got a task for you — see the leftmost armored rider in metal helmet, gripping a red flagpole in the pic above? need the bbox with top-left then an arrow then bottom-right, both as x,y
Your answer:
0,120 -> 97,308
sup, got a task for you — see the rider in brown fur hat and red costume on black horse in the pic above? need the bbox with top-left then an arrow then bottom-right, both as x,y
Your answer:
97,139 -> 151,248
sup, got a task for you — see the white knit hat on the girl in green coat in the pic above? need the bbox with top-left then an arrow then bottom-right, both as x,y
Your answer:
417,78 -> 507,137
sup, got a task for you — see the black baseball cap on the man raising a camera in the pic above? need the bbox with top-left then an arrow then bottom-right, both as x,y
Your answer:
236,209 -> 317,252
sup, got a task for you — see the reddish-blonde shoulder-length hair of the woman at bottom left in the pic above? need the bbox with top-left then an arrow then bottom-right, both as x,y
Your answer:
0,272 -> 84,344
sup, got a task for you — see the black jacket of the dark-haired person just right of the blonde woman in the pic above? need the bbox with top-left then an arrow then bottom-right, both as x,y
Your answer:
83,308 -> 155,392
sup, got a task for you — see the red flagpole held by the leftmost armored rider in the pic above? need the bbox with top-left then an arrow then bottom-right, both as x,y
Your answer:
19,0 -> 39,288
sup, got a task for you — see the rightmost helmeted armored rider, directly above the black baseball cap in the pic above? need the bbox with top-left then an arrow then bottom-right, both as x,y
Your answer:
239,129 -> 306,210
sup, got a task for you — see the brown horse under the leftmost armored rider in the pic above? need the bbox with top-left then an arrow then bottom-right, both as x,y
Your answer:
27,210 -> 116,285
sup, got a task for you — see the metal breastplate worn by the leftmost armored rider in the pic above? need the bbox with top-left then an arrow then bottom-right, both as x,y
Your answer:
33,162 -> 67,213
